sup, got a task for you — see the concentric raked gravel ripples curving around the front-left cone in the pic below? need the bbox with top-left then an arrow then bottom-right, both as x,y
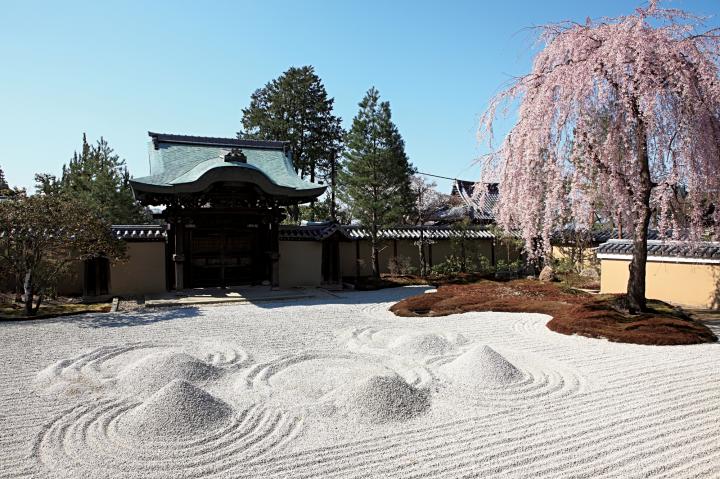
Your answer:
32,400 -> 301,477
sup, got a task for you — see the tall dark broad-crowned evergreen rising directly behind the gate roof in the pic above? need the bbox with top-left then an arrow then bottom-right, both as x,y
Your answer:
238,66 -> 344,219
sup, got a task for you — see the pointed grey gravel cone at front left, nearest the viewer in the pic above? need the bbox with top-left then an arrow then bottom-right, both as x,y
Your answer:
122,379 -> 233,439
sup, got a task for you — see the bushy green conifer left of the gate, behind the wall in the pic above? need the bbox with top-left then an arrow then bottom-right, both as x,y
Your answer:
35,134 -> 149,224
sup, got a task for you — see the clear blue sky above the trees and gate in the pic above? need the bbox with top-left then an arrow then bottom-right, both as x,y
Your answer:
0,0 -> 720,195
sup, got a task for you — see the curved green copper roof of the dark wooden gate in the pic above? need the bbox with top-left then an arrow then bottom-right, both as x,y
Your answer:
131,132 -> 325,200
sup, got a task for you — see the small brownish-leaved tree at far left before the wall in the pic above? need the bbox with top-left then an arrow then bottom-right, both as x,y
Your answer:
0,195 -> 124,315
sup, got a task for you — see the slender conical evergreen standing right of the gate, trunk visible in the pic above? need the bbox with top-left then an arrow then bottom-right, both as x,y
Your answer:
340,87 -> 414,277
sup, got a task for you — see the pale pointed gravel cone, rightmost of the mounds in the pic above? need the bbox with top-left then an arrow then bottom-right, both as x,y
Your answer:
440,346 -> 523,388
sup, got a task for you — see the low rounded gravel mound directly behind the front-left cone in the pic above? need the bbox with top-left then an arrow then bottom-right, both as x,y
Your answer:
118,351 -> 222,396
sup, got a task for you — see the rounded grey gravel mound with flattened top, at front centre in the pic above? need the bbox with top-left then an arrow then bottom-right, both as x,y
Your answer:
324,375 -> 430,424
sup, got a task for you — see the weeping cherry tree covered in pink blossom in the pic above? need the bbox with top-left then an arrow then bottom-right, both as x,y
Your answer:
480,0 -> 720,312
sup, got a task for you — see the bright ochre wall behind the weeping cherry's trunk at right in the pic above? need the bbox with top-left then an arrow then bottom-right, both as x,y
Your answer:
600,259 -> 720,308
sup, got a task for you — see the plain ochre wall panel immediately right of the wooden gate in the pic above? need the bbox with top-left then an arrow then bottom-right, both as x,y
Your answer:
280,241 -> 322,288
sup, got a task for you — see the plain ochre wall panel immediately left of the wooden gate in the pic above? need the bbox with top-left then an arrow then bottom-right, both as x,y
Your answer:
110,241 -> 166,296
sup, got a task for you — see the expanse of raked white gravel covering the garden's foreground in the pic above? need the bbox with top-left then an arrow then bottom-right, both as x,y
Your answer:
0,287 -> 720,478
